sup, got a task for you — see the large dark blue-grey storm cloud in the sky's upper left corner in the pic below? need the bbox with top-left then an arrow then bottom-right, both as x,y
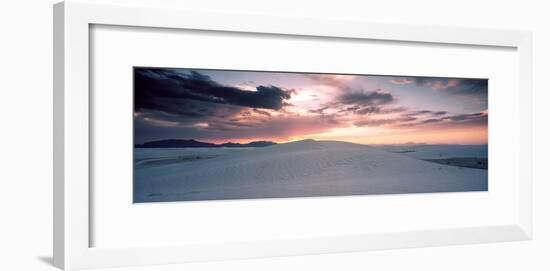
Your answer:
134,68 -> 292,117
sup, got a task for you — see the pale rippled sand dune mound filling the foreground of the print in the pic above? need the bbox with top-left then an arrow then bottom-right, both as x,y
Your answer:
134,140 -> 487,202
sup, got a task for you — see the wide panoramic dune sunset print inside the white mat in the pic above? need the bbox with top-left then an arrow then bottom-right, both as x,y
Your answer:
133,67 -> 489,203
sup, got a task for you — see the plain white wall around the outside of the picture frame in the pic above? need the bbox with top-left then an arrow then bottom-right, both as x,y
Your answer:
0,0 -> 550,271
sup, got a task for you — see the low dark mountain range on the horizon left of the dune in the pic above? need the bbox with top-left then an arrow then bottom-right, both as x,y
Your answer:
134,139 -> 277,148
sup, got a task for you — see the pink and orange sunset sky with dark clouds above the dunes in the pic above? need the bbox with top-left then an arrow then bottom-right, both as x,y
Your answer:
134,67 -> 488,144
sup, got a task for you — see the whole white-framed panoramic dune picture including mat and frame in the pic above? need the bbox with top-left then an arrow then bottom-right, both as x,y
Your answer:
54,1 -> 532,270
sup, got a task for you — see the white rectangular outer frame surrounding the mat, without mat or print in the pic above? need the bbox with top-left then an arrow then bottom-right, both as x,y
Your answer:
54,1 -> 533,270
